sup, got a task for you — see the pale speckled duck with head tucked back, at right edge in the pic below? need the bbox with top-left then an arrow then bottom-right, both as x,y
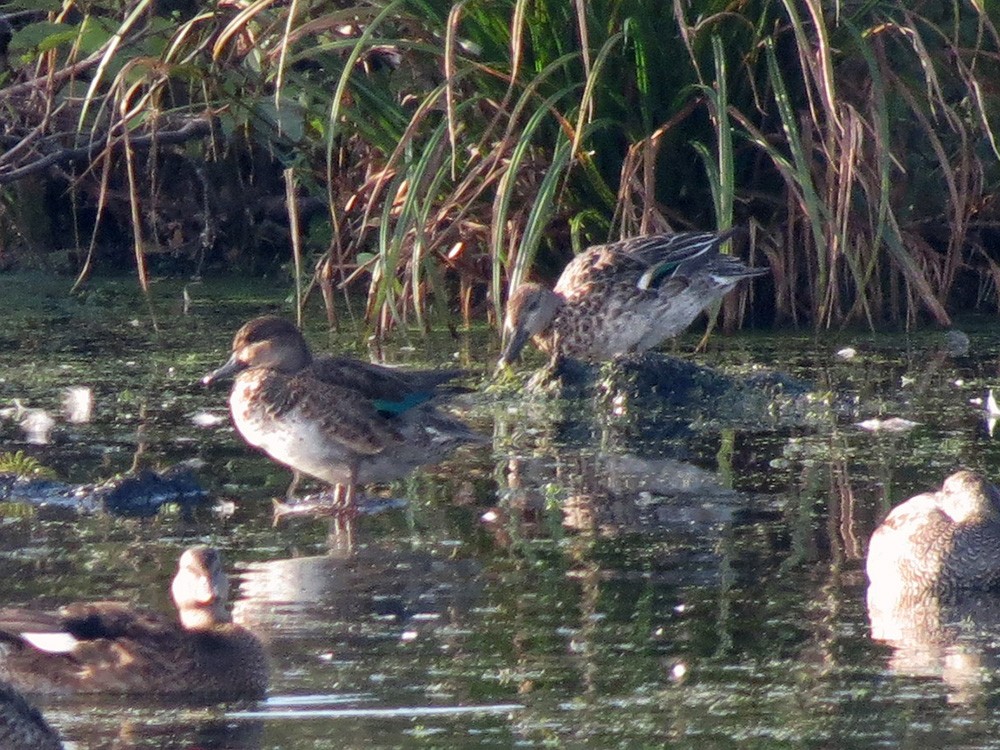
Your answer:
866,470 -> 1000,598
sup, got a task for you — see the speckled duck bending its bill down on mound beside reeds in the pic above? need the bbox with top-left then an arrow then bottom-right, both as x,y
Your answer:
500,229 -> 768,364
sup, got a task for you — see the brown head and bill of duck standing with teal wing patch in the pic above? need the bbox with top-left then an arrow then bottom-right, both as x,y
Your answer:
201,315 -> 312,385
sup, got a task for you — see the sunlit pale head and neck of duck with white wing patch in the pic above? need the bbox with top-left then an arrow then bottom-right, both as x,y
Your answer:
170,545 -> 230,630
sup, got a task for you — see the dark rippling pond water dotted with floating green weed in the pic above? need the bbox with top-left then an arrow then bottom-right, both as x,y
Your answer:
0,278 -> 1000,750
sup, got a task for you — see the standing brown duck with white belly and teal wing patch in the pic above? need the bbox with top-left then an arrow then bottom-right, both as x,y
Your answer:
203,316 -> 484,508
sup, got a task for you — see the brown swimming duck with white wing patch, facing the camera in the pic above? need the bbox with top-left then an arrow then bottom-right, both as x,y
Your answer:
0,546 -> 268,699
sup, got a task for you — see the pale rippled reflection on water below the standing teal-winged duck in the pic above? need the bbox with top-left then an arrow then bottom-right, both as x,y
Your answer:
233,543 -> 483,672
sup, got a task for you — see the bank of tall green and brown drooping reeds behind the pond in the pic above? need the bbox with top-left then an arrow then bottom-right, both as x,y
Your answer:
0,0 -> 1000,331
